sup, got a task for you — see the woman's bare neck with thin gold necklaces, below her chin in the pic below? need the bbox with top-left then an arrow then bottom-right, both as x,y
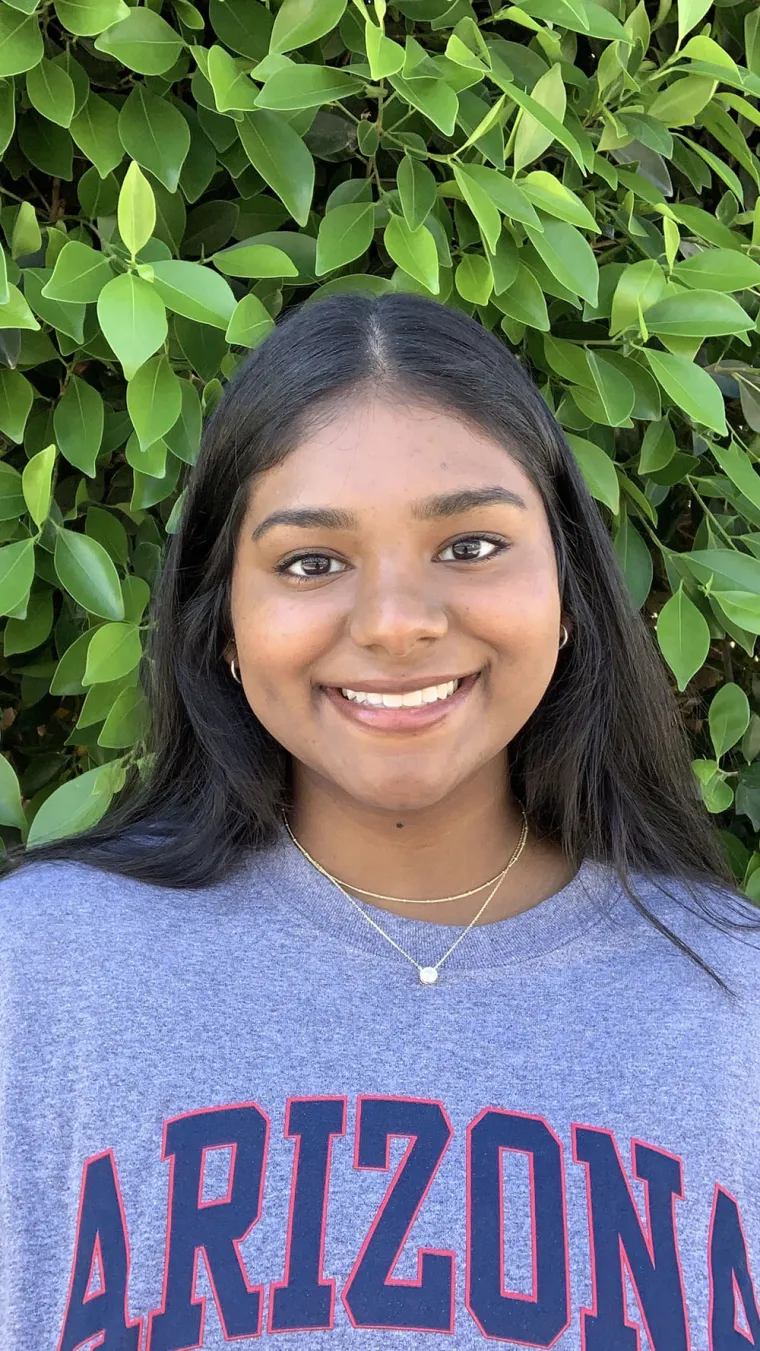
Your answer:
289,759 -> 574,924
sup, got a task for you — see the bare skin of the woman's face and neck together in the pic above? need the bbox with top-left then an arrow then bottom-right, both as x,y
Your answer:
225,396 -> 574,924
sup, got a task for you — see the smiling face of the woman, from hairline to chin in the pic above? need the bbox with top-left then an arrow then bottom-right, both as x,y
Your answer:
227,399 -> 563,812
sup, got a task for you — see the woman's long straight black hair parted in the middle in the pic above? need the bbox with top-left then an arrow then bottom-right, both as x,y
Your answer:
2,293 -> 760,993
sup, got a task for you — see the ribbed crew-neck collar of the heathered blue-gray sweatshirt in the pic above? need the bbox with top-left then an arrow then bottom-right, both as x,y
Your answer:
247,828 -> 624,974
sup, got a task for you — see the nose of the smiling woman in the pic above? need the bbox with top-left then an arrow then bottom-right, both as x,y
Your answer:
348,565 -> 448,657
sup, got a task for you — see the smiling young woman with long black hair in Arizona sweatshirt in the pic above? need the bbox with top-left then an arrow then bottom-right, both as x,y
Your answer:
0,295 -> 760,1351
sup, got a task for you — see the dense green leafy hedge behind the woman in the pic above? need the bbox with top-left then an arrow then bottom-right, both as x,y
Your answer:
0,0 -> 760,901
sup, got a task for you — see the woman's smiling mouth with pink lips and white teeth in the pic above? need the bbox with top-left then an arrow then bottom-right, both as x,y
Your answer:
323,671 -> 479,732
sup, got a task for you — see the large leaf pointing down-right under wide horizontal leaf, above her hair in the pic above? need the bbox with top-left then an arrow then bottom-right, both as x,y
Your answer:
238,109 -> 315,226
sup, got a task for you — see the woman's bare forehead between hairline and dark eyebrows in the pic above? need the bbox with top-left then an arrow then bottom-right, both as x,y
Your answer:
245,399 -> 541,515
